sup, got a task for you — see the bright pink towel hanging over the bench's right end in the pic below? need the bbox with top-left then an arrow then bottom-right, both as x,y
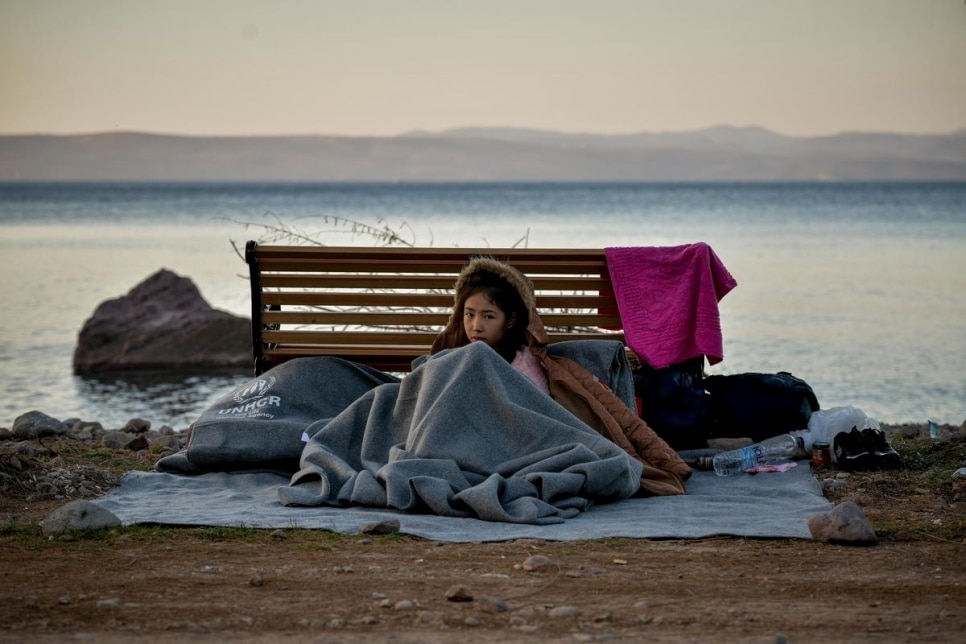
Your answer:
604,242 -> 738,369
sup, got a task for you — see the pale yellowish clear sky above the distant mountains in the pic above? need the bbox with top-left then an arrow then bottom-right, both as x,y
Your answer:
0,0 -> 966,136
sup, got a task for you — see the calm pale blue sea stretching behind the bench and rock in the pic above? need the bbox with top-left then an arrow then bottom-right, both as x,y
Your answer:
0,183 -> 966,429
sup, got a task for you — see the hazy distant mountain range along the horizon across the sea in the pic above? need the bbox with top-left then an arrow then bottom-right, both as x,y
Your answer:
0,126 -> 966,182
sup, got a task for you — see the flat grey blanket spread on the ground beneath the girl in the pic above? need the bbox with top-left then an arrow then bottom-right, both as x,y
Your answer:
95,461 -> 832,543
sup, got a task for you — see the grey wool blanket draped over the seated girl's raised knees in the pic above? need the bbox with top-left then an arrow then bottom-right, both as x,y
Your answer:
279,343 -> 642,524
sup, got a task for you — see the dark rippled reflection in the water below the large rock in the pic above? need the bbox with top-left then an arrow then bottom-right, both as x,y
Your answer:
74,370 -> 252,431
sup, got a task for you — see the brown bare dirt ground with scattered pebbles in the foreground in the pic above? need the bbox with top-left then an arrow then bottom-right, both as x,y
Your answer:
0,426 -> 966,642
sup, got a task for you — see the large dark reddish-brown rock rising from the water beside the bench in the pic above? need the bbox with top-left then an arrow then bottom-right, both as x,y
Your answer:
74,269 -> 253,375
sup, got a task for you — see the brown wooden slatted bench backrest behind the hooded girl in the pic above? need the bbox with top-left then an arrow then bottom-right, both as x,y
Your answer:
245,241 -> 624,375
